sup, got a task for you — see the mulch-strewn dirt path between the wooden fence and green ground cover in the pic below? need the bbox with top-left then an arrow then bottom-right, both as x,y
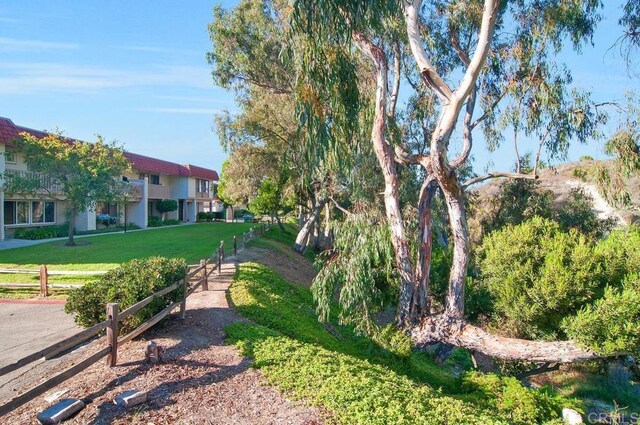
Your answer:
0,250 -> 323,424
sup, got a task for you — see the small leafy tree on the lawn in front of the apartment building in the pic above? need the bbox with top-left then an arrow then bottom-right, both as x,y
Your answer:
4,133 -> 129,246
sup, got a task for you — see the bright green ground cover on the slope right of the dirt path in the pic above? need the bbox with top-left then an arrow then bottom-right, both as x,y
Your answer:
225,234 -> 581,424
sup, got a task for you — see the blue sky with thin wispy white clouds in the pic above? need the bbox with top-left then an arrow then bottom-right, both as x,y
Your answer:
0,0 -> 640,175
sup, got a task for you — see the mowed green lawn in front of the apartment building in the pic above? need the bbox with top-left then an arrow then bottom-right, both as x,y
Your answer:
0,223 -> 256,272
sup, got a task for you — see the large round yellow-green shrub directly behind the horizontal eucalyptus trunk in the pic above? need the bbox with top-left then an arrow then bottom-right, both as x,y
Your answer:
478,217 -> 602,339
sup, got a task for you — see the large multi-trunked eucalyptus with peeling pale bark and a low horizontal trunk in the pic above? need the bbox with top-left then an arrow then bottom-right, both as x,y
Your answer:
294,0 -> 604,362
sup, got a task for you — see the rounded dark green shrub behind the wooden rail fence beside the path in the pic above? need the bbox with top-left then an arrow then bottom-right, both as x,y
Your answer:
65,257 -> 187,332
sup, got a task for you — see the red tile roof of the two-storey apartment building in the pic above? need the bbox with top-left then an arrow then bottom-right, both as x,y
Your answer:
0,117 -> 218,180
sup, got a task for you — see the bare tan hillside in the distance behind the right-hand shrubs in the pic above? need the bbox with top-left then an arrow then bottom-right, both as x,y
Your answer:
472,160 -> 640,224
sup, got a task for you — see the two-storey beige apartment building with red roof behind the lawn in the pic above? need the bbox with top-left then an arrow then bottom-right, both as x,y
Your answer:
0,117 -> 218,240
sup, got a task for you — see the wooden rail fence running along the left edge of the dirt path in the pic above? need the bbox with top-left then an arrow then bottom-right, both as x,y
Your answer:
0,224 -> 269,416
